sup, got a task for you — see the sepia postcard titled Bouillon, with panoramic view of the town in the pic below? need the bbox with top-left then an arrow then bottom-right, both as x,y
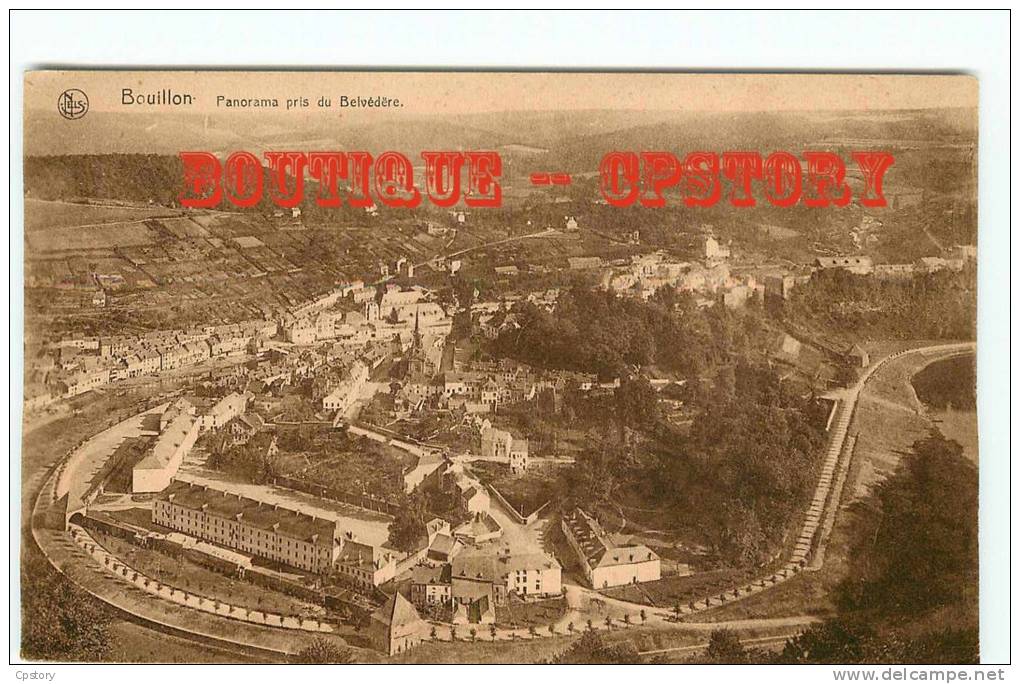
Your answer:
15,70 -> 980,664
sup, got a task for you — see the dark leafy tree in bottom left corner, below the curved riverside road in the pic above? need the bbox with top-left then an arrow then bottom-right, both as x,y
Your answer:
21,553 -> 110,663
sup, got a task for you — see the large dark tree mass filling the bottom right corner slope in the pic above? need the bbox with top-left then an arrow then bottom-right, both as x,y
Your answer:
781,433 -> 978,664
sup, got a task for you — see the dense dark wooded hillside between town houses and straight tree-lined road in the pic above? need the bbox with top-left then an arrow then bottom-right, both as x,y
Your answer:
493,288 -> 827,565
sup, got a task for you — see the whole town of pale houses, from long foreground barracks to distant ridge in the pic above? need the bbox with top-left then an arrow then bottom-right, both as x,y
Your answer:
26,205 -> 976,655
